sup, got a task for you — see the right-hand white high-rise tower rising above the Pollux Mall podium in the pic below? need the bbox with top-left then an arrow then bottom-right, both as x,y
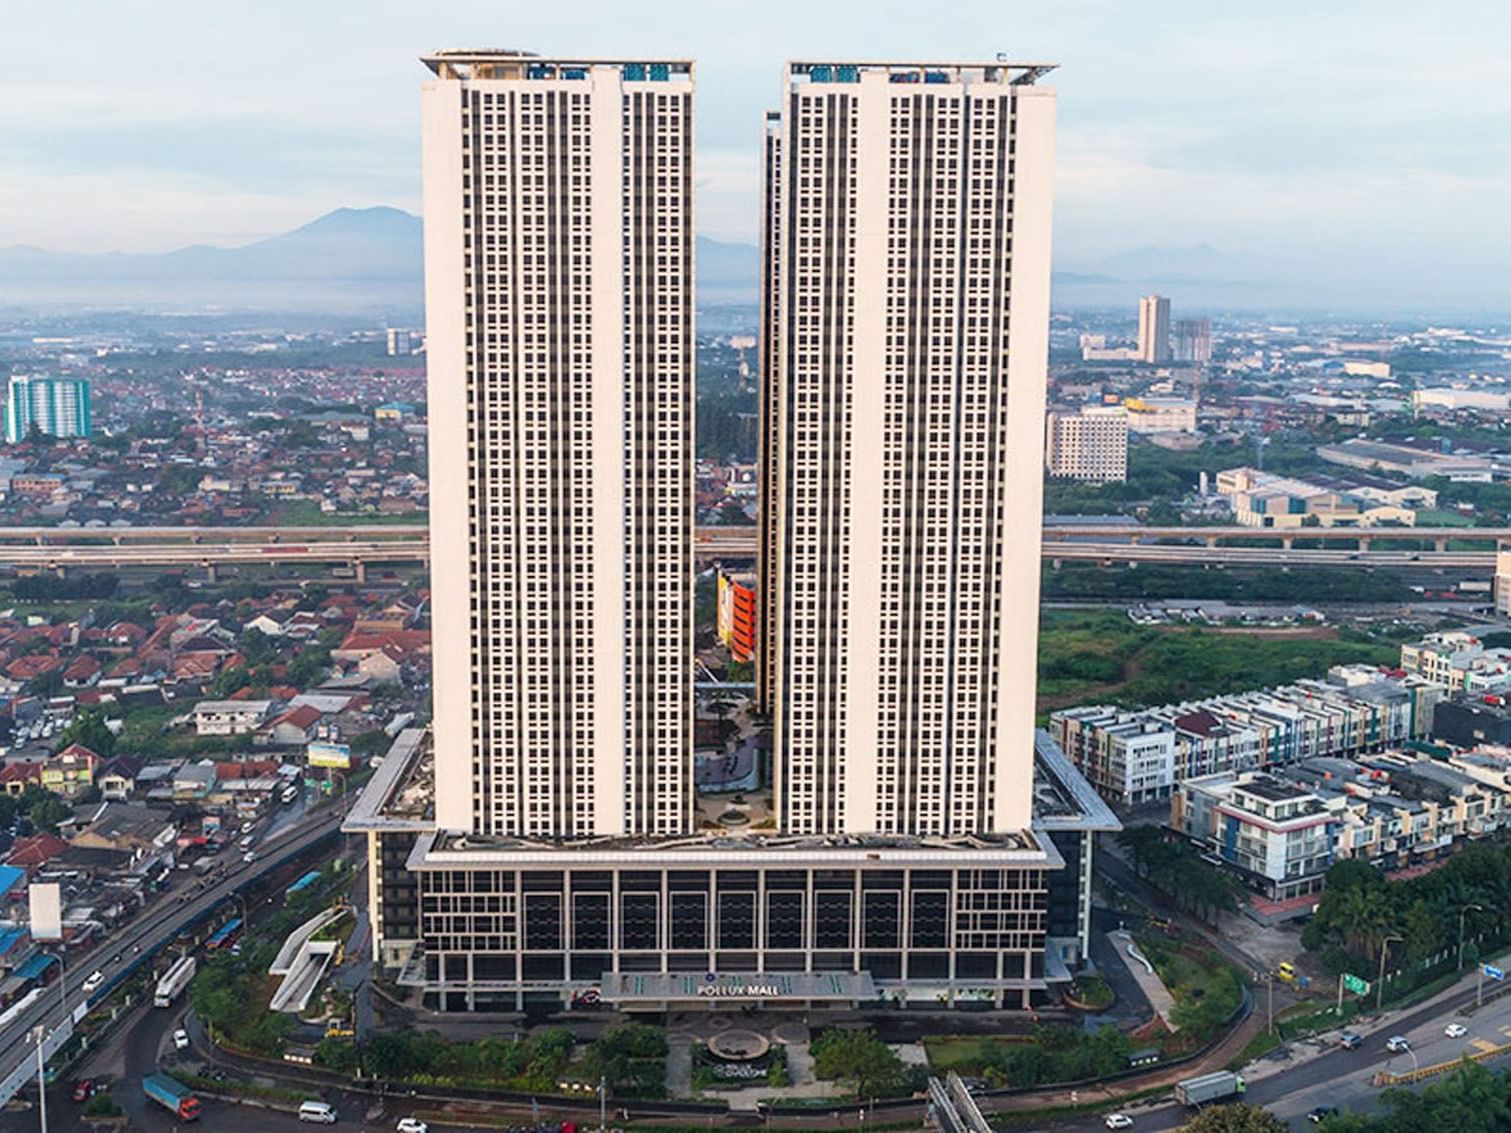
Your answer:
760,62 -> 1055,835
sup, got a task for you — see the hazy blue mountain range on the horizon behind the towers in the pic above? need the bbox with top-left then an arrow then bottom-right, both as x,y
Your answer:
0,207 -> 1274,322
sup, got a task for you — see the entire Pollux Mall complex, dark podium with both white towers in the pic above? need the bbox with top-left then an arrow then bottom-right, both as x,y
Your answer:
349,50 -> 1112,1011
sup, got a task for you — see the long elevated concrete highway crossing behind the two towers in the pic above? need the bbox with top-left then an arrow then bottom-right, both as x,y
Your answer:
0,523 -> 1511,577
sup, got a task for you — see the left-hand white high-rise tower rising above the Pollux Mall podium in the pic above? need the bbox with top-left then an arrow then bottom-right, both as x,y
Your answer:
422,50 -> 694,838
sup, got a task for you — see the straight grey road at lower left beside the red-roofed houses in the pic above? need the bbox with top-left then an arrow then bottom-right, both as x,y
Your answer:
0,807 -> 341,1100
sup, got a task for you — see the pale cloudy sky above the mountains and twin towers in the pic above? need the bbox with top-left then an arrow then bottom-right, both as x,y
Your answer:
0,0 -> 1511,313
